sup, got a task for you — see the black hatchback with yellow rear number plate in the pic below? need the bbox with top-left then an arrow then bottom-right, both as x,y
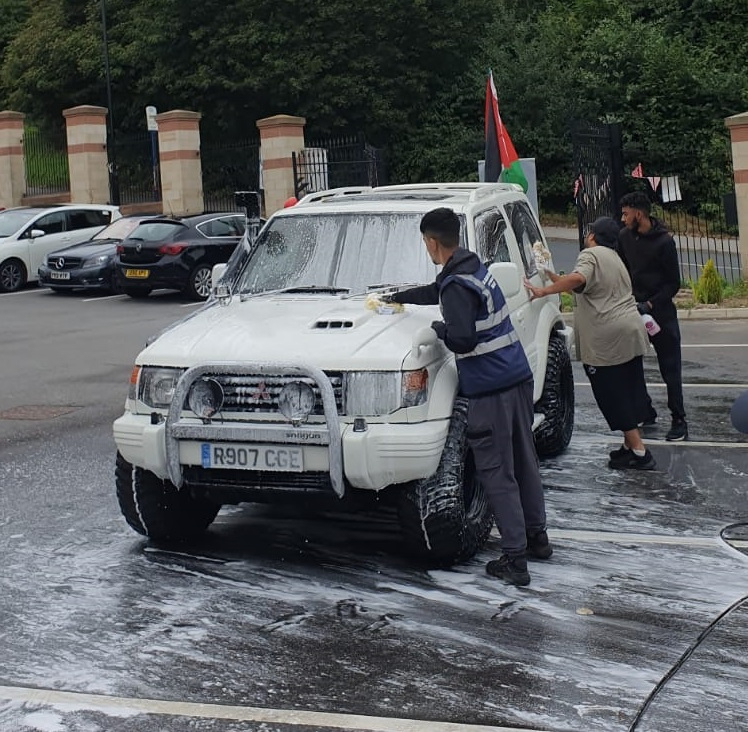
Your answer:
114,212 -> 246,300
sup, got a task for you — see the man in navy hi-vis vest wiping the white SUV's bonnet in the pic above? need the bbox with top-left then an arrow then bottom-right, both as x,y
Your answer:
388,208 -> 553,585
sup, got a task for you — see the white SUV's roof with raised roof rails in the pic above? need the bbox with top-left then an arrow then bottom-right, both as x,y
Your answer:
283,183 -> 522,215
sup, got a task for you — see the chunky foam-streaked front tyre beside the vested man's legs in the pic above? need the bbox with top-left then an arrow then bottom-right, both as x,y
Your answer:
398,399 -> 493,566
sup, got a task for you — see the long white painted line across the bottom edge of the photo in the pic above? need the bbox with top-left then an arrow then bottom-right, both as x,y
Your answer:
0,686 -> 541,732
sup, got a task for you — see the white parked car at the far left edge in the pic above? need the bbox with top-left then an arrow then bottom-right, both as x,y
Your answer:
0,204 -> 120,292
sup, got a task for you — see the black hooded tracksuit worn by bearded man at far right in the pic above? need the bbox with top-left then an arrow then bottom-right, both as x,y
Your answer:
618,218 -> 686,420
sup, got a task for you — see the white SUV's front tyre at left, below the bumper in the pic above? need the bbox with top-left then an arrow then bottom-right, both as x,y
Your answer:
115,453 -> 221,542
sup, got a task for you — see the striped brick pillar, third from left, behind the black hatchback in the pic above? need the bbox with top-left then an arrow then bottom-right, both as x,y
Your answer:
156,109 -> 205,216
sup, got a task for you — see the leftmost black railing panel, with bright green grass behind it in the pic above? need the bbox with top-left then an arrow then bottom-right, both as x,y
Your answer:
23,126 -> 70,196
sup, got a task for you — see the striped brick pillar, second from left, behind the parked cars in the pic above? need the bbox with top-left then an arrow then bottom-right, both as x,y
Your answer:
62,104 -> 110,203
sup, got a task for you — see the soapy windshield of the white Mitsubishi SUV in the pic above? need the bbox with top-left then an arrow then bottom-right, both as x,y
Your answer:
237,213 -> 448,293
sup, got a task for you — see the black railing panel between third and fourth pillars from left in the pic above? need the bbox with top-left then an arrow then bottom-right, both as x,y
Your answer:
200,135 -> 261,211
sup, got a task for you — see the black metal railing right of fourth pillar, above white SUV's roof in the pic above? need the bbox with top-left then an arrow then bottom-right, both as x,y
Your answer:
292,135 -> 386,197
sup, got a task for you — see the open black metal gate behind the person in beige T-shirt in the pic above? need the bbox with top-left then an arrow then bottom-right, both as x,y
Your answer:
571,122 -> 625,249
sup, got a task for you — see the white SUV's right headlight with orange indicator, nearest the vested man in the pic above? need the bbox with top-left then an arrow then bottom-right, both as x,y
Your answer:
344,369 -> 428,417
